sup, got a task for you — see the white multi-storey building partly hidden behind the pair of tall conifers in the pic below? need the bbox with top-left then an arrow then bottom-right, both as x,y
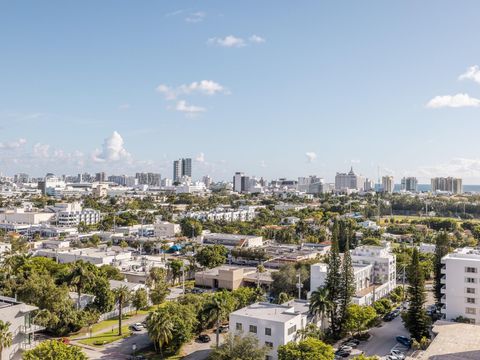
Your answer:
310,243 -> 396,305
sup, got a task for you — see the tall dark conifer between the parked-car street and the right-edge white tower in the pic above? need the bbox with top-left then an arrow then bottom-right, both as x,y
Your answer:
402,248 -> 430,341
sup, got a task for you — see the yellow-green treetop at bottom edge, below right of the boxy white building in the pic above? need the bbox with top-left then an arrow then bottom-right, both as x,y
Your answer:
278,338 -> 335,360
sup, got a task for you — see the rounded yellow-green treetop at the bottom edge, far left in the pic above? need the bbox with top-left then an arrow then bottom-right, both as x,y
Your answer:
22,340 -> 88,360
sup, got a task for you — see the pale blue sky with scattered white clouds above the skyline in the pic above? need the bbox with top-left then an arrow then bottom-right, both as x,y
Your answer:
0,0 -> 480,184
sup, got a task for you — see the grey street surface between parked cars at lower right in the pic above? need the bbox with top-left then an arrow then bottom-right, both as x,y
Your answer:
358,316 -> 410,356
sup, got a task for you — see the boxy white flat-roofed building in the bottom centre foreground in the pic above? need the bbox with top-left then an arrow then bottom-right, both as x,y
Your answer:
229,300 -> 310,360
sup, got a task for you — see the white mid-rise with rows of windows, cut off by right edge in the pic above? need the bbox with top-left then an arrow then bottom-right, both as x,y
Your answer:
440,248 -> 480,324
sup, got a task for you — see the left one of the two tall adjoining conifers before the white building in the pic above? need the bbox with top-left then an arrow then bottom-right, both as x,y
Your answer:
325,232 -> 342,336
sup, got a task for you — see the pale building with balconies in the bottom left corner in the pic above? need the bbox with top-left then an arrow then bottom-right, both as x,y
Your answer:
0,296 -> 44,360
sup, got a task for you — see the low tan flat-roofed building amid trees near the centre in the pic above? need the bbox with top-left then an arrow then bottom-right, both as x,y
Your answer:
195,265 -> 273,290
